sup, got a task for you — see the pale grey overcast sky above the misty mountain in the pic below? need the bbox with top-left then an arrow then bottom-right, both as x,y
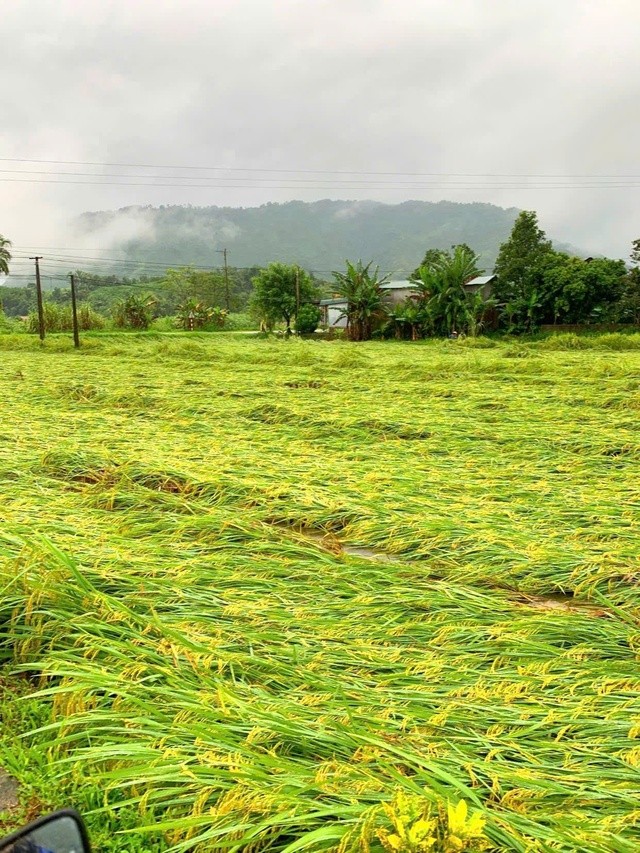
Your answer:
0,0 -> 640,270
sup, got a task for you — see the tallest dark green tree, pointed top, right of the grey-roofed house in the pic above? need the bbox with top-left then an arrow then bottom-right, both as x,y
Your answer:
494,210 -> 553,302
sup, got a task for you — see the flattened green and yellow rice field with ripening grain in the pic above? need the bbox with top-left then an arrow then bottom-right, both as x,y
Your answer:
0,334 -> 640,853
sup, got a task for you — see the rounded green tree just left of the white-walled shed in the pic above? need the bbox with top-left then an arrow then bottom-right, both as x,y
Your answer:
251,262 -> 317,334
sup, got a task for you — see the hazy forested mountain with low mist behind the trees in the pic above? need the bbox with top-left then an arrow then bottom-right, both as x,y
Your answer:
75,200 -> 584,278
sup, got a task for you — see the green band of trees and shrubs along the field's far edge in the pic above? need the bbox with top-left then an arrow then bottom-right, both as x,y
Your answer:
0,211 -> 640,340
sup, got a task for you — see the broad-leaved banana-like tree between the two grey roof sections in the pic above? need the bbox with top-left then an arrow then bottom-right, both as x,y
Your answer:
416,244 -> 481,335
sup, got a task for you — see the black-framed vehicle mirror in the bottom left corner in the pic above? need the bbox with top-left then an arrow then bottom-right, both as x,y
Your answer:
0,809 -> 91,853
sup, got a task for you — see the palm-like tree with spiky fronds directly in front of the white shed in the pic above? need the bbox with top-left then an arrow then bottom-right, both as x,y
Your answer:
333,261 -> 387,341
